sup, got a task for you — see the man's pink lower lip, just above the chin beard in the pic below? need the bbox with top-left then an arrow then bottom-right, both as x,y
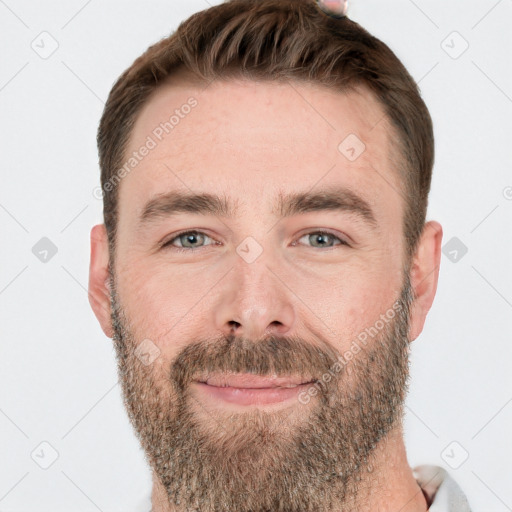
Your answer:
195,382 -> 312,405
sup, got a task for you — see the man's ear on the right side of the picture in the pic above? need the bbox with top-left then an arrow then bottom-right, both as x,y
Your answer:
409,221 -> 443,341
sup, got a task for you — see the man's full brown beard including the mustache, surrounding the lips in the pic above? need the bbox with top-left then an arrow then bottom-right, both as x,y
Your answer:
111,274 -> 413,512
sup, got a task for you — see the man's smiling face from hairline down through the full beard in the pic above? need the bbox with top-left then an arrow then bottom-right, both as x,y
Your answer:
111,81 -> 416,511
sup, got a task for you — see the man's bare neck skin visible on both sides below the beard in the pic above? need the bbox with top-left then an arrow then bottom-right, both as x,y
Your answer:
151,426 -> 427,512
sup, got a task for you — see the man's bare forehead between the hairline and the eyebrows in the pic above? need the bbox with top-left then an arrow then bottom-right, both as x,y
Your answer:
119,76 -> 400,226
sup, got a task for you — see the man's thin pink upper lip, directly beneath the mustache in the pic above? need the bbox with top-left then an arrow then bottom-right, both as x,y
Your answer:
198,373 -> 314,389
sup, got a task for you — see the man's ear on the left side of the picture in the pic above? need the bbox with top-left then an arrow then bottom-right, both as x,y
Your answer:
89,224 -> 113,338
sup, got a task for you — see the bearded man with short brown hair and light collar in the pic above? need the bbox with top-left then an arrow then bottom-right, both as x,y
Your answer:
89,0 -> 469,512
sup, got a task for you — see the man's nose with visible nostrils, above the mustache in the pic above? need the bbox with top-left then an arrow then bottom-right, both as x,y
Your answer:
215,257 -> 296,340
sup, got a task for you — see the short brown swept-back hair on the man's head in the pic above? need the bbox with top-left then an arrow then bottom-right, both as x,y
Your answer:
97,0 -> 434,258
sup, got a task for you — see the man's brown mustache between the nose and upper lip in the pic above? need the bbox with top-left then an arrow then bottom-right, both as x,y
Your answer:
170,335 -> 341,391
